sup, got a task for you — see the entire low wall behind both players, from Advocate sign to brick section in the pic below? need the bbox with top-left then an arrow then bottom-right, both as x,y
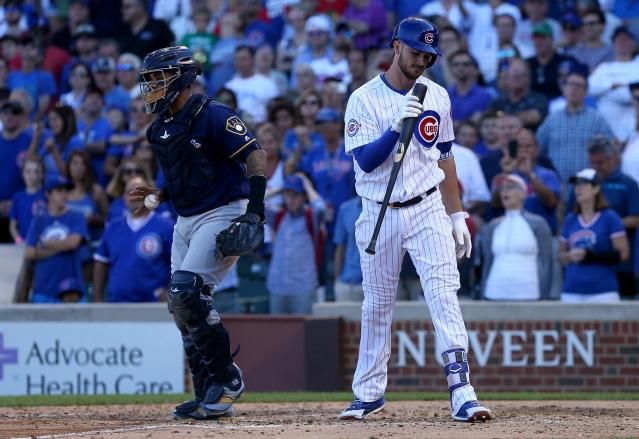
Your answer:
0,302 -> 639,395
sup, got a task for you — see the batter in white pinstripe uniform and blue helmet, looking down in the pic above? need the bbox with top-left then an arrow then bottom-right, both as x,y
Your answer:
339,17 -> 491,422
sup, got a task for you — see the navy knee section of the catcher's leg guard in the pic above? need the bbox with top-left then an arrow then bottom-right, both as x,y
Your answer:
167,270 -> 210,324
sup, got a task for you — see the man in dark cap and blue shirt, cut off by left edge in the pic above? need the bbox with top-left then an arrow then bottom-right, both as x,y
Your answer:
0,100 -> 32,242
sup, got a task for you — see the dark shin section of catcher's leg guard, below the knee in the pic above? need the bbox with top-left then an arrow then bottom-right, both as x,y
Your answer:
189,321 -> 233,383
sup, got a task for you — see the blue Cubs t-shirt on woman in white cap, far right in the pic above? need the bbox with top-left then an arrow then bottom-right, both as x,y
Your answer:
559,209 -> 626,294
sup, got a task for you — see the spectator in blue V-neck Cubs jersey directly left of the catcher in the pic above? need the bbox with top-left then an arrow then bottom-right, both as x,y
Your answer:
93,177 -> 173,302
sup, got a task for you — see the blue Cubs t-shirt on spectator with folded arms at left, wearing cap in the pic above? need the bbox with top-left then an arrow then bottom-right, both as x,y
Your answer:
27,209 -> 87,303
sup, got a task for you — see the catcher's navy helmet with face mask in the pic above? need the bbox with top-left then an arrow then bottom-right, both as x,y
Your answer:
138,46 -> 201,114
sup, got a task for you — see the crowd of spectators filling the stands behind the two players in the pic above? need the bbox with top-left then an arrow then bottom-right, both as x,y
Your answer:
0,0 -> 639,313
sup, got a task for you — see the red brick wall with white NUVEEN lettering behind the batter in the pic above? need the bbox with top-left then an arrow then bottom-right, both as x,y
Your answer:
341,321 -> 639,392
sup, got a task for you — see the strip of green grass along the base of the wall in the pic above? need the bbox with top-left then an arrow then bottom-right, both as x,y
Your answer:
0,392 -> 639,407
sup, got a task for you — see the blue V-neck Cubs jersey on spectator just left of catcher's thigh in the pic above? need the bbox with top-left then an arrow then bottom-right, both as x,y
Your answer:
94,212 -> 173,302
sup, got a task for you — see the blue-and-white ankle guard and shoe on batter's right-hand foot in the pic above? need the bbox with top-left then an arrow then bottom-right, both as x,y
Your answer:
442,348 -> 492,422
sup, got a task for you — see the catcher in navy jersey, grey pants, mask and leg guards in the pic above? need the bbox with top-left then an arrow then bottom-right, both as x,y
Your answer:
129,46 -> 266,419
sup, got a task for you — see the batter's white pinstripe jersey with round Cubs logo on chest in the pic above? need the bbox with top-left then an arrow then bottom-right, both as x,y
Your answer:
344,75 -> 455,202
